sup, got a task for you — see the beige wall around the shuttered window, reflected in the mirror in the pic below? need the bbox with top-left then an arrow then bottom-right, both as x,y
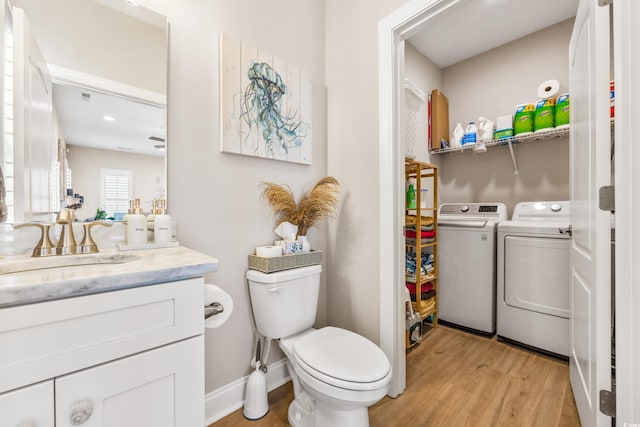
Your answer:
67,145 -> 164,220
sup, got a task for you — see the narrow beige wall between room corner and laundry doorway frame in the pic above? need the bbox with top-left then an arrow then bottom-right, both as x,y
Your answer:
326,0 -> 405,342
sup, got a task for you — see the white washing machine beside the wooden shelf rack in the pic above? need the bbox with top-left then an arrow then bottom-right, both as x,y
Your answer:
437,203 -> 507,336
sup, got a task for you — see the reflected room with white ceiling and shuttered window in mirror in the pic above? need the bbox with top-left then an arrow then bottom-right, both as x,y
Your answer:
53,84 -> 165,224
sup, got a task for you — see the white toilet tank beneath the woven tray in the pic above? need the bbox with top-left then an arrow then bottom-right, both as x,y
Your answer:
247,265 -> 322,339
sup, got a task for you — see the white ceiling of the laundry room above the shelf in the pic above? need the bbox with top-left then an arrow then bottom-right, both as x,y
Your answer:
407,0 -> 579,68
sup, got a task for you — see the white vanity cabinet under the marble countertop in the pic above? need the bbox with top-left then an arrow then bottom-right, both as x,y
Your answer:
0,278 -> 204,427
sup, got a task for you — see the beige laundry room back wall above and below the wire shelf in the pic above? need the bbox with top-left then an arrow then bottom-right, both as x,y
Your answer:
432,20 -> 573,215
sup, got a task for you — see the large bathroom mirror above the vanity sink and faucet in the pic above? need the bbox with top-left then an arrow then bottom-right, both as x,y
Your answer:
2,0 -> 168,222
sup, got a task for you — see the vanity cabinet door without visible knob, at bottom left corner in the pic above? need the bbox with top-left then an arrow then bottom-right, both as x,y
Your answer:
0,380 -> 54,427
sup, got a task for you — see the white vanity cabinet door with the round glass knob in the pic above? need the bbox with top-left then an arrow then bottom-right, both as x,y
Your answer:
56,336 -> 204,427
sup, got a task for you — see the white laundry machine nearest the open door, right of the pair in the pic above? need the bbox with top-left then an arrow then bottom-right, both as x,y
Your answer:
497,201 -> 570,357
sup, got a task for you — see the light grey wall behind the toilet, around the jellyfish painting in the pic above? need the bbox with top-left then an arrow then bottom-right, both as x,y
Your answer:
149,0 -> 328,398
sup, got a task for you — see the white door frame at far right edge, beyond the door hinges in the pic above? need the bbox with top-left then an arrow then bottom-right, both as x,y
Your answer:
613,0 -> 640,426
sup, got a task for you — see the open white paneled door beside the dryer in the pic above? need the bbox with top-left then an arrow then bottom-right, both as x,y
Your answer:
569,0 -> 611,427
